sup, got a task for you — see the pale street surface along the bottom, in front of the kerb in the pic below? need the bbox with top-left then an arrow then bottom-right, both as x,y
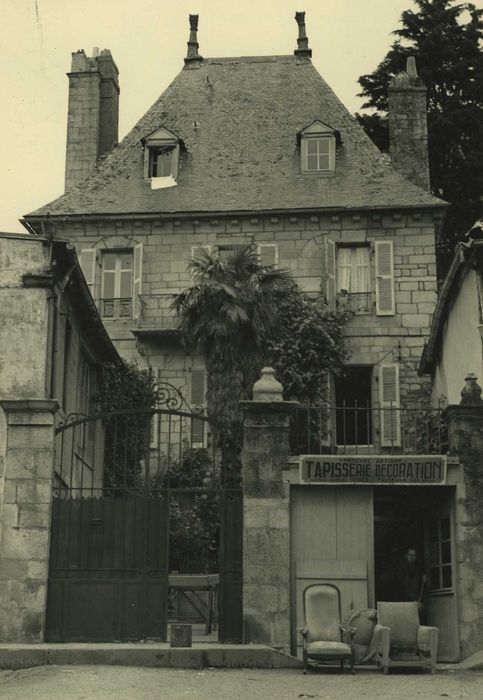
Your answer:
0,666 -> 483,700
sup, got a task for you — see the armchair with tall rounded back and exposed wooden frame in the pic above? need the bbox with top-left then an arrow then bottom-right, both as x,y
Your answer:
300,583 -> 354,673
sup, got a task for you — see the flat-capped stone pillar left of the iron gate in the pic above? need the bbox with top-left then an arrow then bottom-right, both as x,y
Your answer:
0,399 -> 58,642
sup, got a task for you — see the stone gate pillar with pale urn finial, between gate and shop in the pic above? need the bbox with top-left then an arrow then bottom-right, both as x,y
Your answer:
242,368 -> 296,651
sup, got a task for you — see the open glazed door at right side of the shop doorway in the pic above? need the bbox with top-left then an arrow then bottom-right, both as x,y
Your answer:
424,489 -> 460,661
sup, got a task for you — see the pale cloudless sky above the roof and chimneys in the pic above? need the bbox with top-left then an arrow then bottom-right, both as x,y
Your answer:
0,0 -> 483,232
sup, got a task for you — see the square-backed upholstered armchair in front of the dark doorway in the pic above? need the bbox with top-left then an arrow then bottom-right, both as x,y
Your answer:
371,602 -> 439,673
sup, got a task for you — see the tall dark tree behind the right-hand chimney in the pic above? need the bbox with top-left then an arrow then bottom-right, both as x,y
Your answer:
357,0 -> 483,270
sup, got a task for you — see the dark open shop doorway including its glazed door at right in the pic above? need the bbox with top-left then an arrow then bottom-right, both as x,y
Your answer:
374,486 -> 460,661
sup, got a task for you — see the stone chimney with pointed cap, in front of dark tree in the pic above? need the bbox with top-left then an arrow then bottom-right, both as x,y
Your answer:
389,56 -> 430,191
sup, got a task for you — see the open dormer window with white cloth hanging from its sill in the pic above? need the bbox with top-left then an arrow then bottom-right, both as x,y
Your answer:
142,127 -> 180,190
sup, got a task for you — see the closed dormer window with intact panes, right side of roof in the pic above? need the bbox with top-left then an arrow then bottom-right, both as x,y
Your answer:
298,120 -> 340,175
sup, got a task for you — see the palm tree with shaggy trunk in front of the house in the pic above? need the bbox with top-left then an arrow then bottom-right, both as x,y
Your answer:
174,245 -> 293,463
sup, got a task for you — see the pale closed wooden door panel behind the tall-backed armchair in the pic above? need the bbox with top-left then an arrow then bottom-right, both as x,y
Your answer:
291,486 -> 374,653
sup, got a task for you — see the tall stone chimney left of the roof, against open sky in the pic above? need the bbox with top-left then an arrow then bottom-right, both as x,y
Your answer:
65,48 -> 119,192
